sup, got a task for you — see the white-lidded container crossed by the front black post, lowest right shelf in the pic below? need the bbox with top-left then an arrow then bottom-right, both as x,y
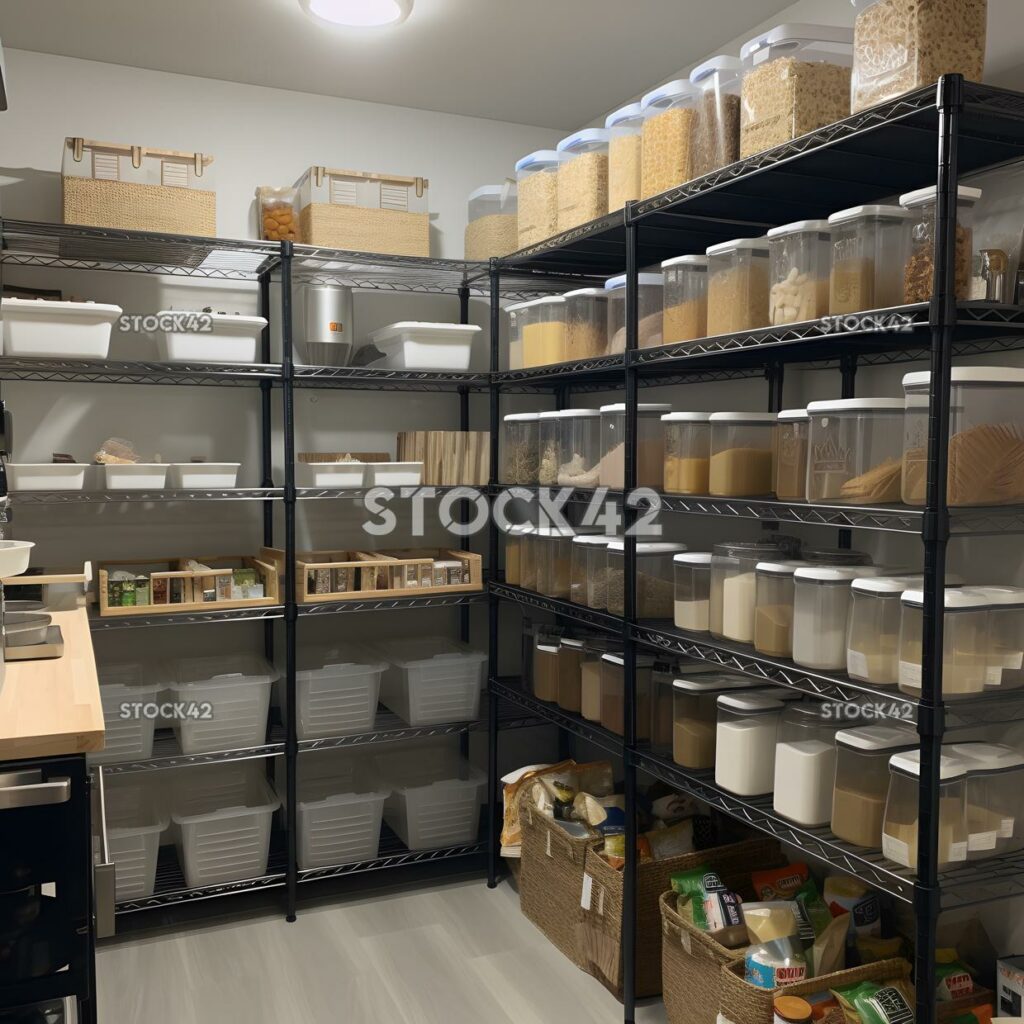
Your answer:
882,746 -> 968,871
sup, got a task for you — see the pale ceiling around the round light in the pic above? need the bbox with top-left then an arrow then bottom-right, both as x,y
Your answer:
0,0 -> 793,131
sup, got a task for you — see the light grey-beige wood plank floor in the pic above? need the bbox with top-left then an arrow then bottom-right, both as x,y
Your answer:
97,880 -> 666,1024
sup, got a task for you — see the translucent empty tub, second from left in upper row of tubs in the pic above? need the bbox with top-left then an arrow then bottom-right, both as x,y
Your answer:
169,654 -> 278,754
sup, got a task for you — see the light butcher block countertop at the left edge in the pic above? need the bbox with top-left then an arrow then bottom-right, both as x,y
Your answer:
0,608 -> 103,761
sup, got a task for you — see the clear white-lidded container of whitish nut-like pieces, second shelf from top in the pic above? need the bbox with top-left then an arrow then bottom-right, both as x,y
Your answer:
768,220 -> 831,326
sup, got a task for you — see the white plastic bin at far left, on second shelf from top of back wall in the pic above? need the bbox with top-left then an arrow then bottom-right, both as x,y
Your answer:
0,299 -> 121,359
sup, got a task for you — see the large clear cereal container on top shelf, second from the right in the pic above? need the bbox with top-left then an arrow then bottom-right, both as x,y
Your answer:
739,25 -> 853,157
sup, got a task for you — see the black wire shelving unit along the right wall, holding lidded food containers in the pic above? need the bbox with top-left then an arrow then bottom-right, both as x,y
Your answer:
487,75 -> 1024,1024
